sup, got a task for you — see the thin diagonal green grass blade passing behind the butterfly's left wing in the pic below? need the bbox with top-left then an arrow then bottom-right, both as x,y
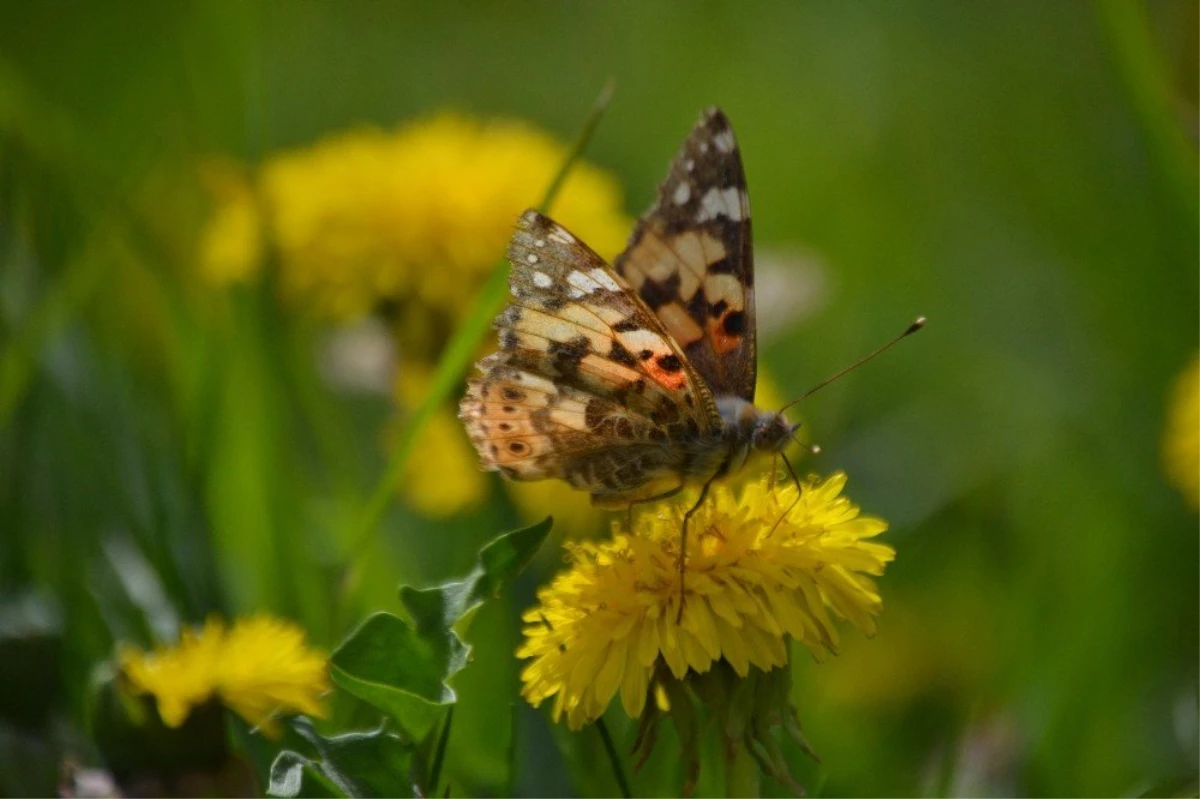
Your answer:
338,80 -> 613,573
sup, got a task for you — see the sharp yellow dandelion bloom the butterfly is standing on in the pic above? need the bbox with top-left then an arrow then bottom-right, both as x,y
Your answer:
517,473 -> 894,728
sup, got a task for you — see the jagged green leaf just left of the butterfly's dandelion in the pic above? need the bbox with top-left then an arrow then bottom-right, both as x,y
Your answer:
330,517 -> 552,740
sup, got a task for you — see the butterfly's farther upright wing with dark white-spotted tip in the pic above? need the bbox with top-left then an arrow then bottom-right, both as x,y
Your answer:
614,109 -> 757,402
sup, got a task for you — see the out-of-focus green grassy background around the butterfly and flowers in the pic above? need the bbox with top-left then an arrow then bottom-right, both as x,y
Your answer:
0,0 -> 1200,797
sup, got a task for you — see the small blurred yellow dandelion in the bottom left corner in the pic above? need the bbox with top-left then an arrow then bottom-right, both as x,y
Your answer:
118,614 -> 330,735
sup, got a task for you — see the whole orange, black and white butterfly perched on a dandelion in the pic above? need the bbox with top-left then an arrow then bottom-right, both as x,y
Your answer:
460,109 -> 794,507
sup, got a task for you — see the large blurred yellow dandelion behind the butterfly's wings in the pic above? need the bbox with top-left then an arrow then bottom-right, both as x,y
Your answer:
205,113 -> 630,324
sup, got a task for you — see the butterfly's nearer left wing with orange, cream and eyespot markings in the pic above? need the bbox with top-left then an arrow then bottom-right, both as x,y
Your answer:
460,211 -> 722,506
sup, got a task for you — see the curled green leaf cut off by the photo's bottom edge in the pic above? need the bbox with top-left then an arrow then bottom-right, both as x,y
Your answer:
268,717 -> 414,799
